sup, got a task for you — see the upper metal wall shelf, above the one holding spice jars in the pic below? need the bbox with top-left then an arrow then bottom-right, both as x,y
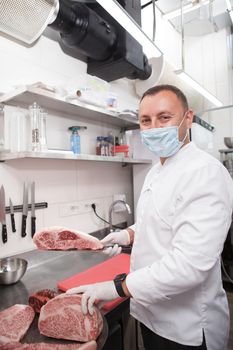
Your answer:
0,84 -> 139,129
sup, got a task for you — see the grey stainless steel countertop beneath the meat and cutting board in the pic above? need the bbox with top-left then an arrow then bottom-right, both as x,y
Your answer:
0,250 -> 109,349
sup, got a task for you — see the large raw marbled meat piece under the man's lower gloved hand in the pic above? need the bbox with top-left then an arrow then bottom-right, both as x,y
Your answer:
38,294 -> 103,342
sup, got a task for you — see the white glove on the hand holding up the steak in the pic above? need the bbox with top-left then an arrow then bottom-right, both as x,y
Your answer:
101,230 -> 130,257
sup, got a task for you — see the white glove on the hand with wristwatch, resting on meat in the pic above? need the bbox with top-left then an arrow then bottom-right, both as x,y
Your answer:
66,281 -> 119,315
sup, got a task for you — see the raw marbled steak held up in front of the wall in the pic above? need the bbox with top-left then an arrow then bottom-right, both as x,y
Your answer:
33,226 -> 103,250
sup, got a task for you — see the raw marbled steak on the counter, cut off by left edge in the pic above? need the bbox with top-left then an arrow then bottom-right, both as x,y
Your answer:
0,304 -> 35,344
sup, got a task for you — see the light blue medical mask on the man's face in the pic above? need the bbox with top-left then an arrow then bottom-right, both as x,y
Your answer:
141,113 -> 187,158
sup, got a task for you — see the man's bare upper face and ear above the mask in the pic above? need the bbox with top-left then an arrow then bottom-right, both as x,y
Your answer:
139,91 -> 193,140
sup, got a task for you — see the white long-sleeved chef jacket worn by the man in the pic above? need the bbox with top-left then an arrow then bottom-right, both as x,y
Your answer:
126,142 -> 233,350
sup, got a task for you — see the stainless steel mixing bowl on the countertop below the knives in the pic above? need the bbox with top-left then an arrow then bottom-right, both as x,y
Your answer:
0,258 -> 28,284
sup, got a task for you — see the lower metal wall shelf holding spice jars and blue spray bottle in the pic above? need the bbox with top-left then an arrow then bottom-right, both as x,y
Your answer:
0,151 -> 152,164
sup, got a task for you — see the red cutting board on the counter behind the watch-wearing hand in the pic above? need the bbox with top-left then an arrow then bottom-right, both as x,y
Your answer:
57,254 -> 130,310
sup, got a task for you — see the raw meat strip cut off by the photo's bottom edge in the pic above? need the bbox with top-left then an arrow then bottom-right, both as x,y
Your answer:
0,340 -> 97,350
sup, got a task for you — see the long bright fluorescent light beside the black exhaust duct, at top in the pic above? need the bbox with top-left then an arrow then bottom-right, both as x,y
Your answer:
94,0 -> 162,58
